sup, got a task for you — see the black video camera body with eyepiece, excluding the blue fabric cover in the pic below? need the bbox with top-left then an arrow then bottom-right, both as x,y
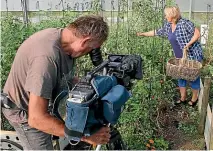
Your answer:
70,48 -> 142,103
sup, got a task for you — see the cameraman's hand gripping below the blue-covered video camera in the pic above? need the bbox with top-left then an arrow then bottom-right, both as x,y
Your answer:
81,127 -> 110,145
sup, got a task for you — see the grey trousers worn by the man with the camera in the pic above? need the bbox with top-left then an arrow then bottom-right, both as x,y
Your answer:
2,108 -> 53,150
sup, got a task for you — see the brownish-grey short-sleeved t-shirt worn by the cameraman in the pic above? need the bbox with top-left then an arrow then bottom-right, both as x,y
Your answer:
4,28 -> 74,121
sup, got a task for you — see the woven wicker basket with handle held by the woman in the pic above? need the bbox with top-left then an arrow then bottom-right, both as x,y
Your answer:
166,48 -> 202,81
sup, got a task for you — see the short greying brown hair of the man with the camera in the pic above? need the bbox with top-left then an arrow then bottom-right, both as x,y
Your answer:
68,15 -> 109,43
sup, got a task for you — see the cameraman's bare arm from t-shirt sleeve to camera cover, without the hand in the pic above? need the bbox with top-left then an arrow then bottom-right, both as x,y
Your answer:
28,93 -> 64,137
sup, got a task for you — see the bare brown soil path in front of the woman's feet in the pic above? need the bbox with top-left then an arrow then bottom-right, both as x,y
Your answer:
157,101 -> 205,150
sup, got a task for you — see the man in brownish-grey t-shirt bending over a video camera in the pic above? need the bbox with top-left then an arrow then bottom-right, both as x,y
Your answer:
2,15 -> 110,150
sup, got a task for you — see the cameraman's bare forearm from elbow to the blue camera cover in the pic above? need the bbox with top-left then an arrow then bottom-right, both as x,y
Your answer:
28,113 -> 64,137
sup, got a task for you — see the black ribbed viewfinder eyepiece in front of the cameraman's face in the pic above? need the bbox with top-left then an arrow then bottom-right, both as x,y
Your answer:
90,47 -> 103,66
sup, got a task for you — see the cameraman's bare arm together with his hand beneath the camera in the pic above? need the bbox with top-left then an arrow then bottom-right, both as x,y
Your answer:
28,93 -> 110,144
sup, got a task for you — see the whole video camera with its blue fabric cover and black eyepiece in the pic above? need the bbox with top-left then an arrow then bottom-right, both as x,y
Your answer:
53,48 -> 142,141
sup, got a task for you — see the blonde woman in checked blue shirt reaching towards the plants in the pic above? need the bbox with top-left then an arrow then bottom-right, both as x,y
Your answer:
137,6 -> 203,106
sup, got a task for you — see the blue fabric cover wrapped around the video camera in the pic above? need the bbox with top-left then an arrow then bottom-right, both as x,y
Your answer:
65,76 -> 130,141
